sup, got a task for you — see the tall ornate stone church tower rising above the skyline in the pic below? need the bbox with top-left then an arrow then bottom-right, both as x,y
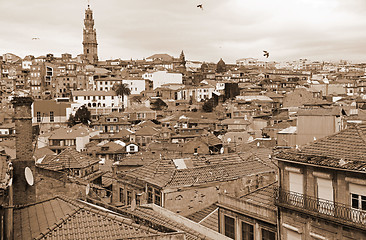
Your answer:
83,5 -> 98,64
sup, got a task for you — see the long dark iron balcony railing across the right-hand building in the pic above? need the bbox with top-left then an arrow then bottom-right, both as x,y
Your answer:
275,189 -> 366,230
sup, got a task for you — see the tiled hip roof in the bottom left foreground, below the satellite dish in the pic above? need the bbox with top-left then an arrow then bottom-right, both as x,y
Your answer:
14,197 -> 159,240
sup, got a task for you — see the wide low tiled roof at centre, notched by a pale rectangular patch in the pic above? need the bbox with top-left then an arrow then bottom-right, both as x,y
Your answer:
120,154 -> 274,187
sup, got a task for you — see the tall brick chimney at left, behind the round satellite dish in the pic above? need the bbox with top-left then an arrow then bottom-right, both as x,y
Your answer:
11,97 -> 36,205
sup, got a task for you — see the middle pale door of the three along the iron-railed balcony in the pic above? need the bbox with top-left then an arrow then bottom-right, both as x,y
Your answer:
316,178 -> 334,215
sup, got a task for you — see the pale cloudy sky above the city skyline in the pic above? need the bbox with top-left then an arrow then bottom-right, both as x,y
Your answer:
0,0 -> 366,63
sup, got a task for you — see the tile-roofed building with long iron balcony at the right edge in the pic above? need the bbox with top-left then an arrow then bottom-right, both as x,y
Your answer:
275,125 -> 366,240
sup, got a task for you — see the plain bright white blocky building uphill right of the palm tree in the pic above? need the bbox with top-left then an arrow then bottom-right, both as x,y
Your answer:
142,71 -> 183,89
